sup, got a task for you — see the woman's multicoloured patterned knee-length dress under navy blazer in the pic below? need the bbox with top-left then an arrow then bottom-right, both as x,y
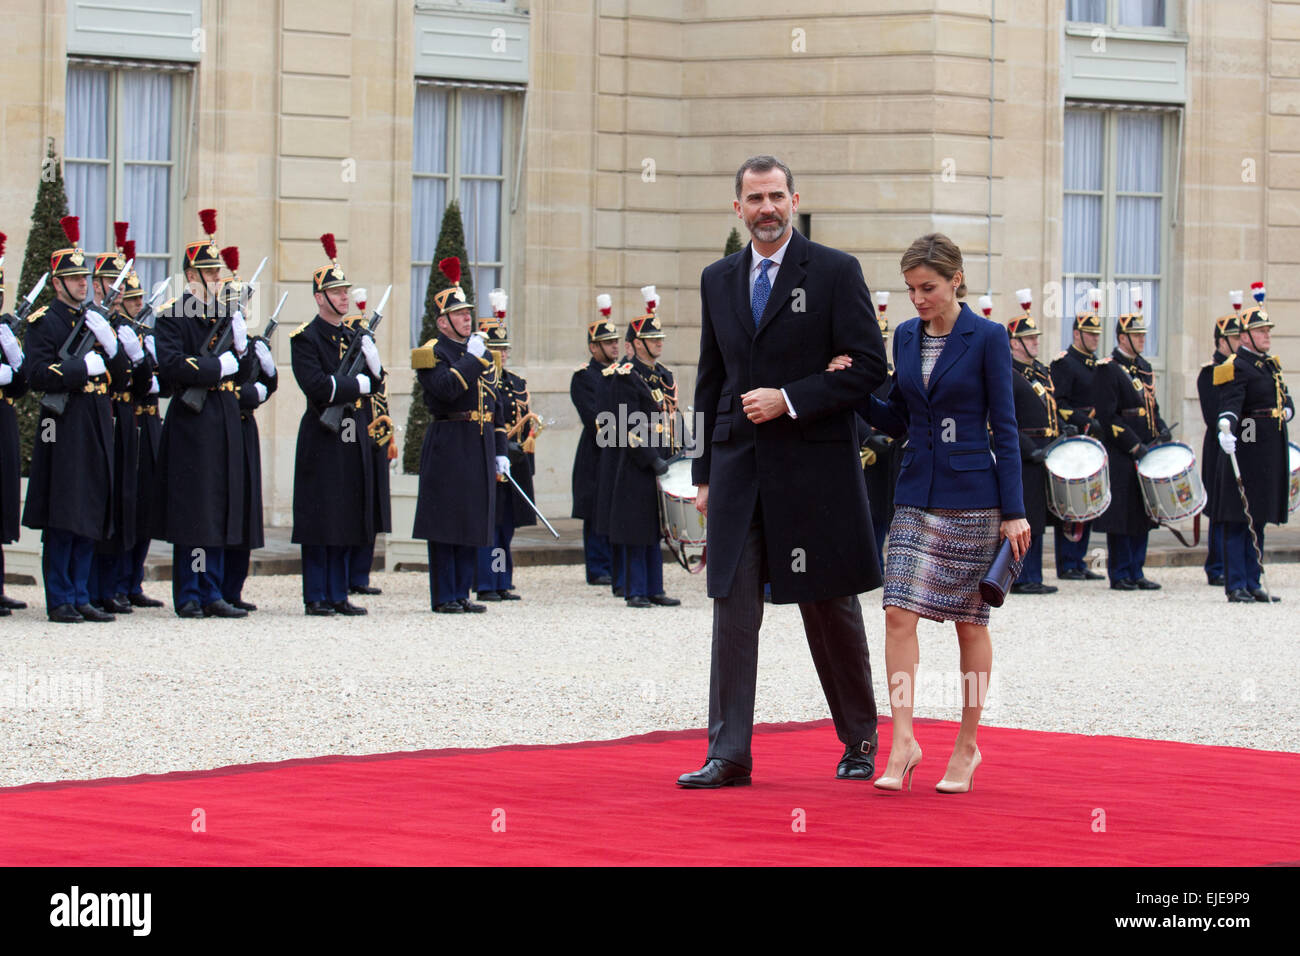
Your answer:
881,332 -> 1019,624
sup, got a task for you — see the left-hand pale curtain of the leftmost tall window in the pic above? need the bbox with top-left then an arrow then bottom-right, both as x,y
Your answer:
64,68 -> 112,254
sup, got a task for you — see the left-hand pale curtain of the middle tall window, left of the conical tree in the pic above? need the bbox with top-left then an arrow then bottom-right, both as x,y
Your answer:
411,86 -> 449,346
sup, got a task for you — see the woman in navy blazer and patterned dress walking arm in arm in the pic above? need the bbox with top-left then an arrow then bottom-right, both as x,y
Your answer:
833,233 -> 1030,793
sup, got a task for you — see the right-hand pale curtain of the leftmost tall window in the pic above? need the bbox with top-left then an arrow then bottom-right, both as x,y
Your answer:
120,70 -> 174,290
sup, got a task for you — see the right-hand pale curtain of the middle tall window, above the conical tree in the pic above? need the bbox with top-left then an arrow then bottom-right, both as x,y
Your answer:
460,91 -> 506,300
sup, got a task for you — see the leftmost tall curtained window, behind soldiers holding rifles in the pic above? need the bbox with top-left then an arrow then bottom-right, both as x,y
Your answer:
64,65 -> 189,289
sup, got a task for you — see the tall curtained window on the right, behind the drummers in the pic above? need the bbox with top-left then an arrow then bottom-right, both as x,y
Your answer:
1062,109 -> 1170,356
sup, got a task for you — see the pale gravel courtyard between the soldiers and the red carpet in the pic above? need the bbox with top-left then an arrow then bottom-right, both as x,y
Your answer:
0,564 -> 1300,786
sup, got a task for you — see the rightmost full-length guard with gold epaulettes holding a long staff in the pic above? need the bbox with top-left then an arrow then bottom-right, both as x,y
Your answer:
1212,282 -> 1295,604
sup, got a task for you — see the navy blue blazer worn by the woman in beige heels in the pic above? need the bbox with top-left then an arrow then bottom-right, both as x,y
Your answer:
859,303 -> 1024,520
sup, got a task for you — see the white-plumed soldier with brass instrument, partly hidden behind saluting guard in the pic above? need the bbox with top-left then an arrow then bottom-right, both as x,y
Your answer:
475,289 -> 537,601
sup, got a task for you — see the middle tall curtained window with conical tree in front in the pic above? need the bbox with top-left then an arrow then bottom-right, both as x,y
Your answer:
411,83 -> 511,345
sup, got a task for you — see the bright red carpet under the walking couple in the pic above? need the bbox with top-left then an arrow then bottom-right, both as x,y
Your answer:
0,721 -> 1300,866
